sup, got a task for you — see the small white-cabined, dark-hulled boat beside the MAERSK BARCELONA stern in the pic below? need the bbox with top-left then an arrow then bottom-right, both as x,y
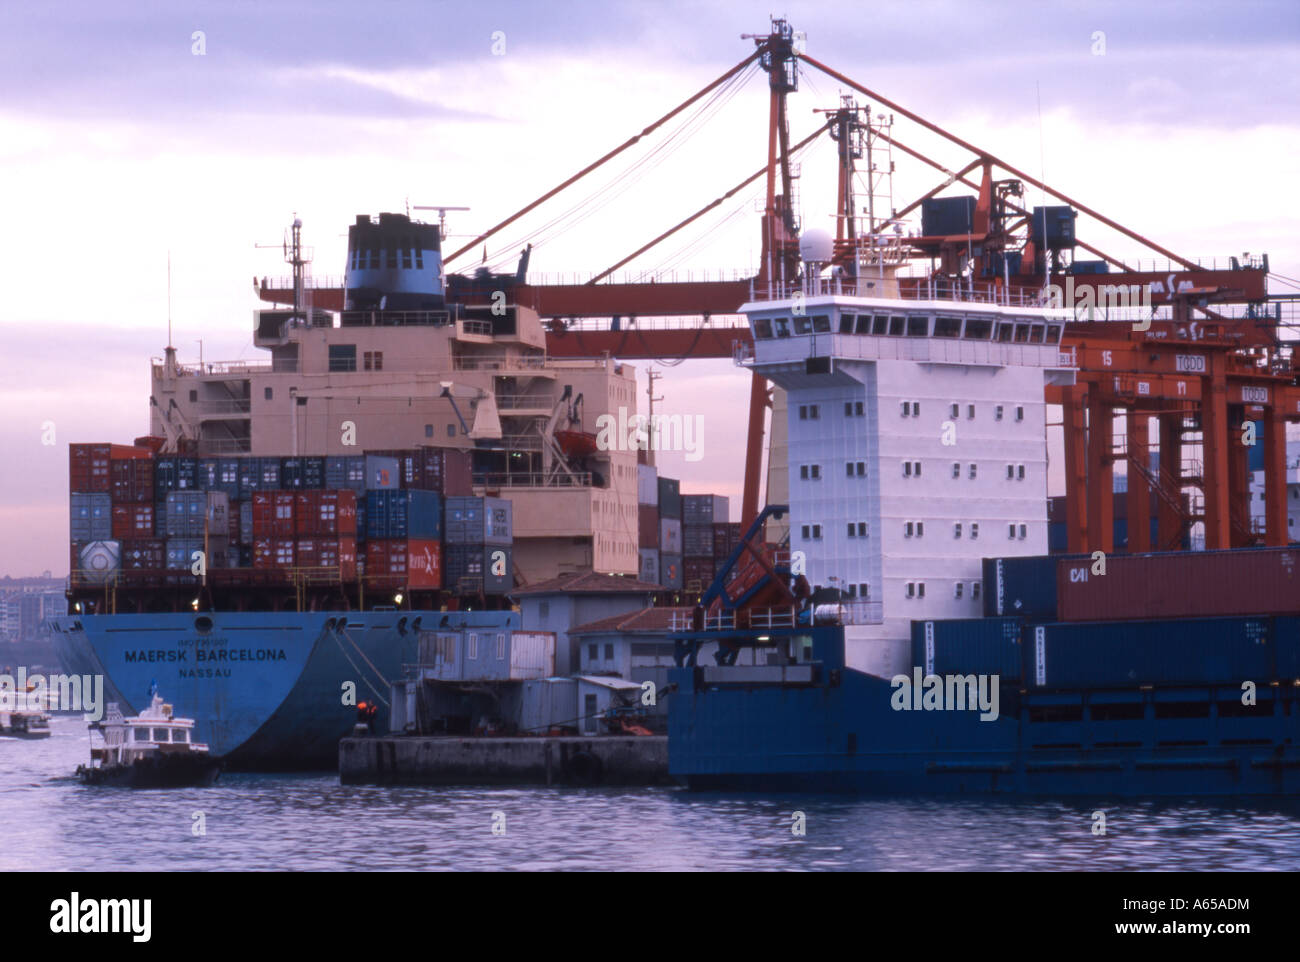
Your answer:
77,689 -> 221,788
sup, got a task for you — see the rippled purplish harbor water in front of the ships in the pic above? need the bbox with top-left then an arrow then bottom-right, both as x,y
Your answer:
0,715 -> 1300,871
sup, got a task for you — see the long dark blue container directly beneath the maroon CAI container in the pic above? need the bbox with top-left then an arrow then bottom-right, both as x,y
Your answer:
1024,618 -> 1275,689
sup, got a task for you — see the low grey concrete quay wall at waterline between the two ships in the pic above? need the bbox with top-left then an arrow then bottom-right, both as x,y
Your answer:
338,735 -> 672,785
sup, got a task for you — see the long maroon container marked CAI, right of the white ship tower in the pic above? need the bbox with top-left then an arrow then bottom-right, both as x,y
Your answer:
1057,547 -> 1300,621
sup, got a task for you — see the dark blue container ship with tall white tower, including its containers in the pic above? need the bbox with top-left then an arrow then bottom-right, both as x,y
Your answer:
668,228 -> 1300,796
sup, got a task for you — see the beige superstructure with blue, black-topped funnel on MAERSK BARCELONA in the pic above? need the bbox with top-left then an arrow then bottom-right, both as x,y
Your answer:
150,213 -> 638,582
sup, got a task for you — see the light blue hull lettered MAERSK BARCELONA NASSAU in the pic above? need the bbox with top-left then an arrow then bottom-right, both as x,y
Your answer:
53,611 -> 519,771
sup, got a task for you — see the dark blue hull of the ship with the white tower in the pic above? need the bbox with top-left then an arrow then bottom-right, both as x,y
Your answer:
668,628 -> 1300,796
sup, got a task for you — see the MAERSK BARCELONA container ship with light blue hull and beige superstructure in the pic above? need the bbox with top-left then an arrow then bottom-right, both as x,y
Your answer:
52,213 -> 640,770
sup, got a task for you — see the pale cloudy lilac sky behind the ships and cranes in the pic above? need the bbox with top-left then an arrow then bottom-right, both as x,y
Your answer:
0,0 -> 1300,576
